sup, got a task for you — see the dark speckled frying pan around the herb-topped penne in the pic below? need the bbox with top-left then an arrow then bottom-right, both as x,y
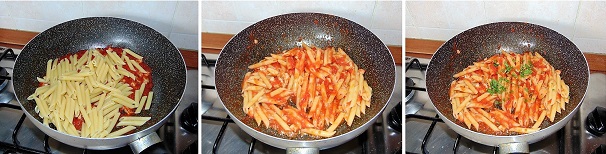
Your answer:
425,22 -> 589,152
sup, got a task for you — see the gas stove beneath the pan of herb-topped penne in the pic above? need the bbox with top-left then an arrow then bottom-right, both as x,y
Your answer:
404,57 -> 606,153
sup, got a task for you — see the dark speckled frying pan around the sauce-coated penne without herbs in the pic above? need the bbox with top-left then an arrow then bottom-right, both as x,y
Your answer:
215,13 -> 395,151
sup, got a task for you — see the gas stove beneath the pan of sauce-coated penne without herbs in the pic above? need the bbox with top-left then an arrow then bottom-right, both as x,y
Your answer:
199,53 -> 402,154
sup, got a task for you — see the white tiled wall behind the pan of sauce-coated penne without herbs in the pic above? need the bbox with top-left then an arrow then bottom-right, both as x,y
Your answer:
201,1 -> 403,46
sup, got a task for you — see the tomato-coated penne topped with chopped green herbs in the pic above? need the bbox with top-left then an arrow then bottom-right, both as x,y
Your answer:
448,50 -> 569,135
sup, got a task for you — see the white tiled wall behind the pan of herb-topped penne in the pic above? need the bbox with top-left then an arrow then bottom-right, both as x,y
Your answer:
405,1 -> 606,53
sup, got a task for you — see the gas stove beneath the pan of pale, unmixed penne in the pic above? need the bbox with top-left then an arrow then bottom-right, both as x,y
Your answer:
0,47 -> 198,153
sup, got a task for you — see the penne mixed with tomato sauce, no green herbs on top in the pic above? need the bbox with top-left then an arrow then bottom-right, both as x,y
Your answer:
242,44 -> 372,137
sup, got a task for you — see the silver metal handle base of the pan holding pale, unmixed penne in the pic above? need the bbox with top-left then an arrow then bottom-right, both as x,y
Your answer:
128,132 -> 170,154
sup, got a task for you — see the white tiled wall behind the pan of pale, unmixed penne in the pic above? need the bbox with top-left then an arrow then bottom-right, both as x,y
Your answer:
0,1 -> 199,50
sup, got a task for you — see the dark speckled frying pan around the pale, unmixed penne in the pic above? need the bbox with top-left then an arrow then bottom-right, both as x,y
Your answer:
13,17 -> 186,152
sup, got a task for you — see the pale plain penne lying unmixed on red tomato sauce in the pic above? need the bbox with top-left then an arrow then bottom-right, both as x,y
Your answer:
27,47 -> 153,138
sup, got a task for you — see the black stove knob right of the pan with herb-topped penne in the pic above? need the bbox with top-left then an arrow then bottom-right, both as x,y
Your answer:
585,106 -> 606,136
